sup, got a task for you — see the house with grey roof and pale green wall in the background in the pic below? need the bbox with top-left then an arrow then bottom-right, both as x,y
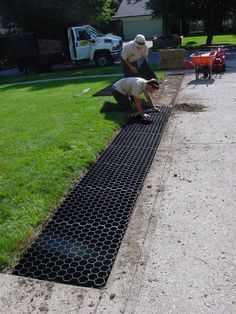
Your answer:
113,0 -> 162,40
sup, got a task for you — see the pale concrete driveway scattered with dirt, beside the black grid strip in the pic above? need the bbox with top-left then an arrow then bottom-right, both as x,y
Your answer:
0,64 -> 236,314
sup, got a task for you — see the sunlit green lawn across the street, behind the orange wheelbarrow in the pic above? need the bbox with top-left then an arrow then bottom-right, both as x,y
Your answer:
182,34 -> 236,48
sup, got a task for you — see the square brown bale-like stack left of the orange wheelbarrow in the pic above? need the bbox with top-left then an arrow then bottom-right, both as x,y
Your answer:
159,49 -> 185,70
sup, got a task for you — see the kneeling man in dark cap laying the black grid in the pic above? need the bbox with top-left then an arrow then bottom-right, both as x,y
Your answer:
100,77 -> 160,119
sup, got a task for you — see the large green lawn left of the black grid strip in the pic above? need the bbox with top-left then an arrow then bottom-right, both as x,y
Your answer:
0,77 -> 127,268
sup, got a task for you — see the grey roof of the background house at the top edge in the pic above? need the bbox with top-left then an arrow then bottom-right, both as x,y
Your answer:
114,0 -> 152,18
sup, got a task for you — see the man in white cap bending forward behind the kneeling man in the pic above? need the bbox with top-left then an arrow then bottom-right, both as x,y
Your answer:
121,34 -> 148,77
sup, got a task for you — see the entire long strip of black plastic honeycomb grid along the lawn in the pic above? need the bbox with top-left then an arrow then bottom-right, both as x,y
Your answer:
13,108 -> 171,288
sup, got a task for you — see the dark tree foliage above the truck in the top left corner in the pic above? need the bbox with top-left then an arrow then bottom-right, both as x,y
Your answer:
0,0 -> 113,32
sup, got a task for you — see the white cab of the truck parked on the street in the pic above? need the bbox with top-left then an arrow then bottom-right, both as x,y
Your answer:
68,25 -> 123,67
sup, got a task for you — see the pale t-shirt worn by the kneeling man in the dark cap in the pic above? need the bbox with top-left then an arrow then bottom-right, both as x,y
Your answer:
113,77 -> 149,97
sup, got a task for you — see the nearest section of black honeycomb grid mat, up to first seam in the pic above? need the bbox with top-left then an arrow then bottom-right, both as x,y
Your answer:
14,186 -> 138,287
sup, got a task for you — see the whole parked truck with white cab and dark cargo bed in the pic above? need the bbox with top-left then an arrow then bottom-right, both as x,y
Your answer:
0,25 -> 123,74
